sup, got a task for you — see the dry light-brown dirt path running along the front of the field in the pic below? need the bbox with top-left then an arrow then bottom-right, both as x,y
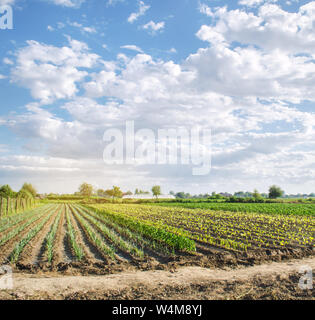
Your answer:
0,257 -> 315,299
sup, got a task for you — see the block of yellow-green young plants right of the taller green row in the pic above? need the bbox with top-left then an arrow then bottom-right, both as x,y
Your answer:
92,204 -> 315,250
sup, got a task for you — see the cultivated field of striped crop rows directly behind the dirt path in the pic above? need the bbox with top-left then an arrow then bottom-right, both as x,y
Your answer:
0,203 -> 315,274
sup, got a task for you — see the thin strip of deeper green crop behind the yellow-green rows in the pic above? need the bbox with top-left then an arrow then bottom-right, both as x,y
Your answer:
150,202 -> 315,217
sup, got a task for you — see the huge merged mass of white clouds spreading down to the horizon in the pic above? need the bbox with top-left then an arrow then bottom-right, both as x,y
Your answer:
0,2 -> 315,192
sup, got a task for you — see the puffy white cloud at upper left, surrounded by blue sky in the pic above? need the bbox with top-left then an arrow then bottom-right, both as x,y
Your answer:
12,39 -> 99,103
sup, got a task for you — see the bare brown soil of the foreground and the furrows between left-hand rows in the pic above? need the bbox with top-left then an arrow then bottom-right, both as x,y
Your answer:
0,206 -> 315,300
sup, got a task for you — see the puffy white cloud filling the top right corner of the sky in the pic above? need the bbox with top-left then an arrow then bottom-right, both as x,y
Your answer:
198,1 -> 315,55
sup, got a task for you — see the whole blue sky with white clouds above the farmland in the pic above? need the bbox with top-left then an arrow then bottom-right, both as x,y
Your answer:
0,0 -> 315,193
